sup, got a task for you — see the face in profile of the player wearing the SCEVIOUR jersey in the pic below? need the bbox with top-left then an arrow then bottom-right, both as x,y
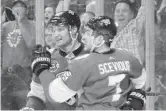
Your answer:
82,28 -> 93,51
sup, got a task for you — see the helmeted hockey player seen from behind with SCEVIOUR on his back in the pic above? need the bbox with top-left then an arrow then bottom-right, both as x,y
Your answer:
29,16 -> 145,110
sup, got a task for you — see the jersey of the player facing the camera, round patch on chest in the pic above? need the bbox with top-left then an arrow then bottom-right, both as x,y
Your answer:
28,44 -> 86,110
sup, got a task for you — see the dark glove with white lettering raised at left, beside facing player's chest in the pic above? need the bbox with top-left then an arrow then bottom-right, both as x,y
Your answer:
31,45 -> 51,77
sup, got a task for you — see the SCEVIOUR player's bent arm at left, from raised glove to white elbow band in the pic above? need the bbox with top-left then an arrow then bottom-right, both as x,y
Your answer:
31,46 -> 87,106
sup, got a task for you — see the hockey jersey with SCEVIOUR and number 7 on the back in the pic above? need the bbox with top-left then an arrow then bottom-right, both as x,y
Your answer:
57,50 -> 144,110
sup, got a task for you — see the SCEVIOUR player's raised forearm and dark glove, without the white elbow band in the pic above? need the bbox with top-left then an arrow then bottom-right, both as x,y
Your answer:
31,45 -> 58,105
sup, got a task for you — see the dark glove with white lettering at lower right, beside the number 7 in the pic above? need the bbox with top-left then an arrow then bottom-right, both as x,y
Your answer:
120,89 -> 146,110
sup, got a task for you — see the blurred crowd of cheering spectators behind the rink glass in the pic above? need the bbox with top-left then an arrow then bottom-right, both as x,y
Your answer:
1,0 -> 166,110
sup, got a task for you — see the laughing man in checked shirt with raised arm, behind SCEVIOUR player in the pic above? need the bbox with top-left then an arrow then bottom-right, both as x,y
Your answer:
111,0 -> 145,66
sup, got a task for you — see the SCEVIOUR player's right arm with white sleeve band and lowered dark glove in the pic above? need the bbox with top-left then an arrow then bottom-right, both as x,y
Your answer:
121,57 -> 146,110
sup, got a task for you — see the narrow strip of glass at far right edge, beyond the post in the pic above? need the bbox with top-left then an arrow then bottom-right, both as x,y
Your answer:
155,0 -> 166,110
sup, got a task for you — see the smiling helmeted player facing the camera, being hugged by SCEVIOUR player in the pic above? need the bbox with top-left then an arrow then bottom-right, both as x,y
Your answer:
24,10 -> 84,110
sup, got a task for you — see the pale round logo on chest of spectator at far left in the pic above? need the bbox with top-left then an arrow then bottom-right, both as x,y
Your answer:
7,29 -> 22,47
